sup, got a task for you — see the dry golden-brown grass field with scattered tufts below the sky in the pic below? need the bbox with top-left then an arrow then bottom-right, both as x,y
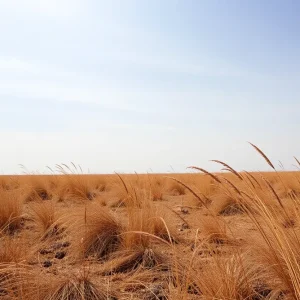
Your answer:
0,149 -> 300,300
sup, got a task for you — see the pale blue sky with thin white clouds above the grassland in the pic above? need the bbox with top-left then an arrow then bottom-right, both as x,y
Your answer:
0,0 -> 300,174
